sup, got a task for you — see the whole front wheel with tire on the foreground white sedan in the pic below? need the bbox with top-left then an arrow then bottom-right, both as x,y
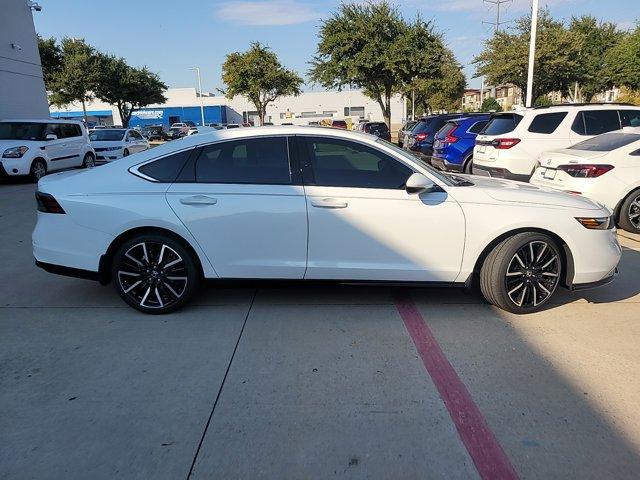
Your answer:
480,232 -> 562,313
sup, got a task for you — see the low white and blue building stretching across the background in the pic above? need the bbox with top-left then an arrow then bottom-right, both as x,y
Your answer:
51,88 -> 405,127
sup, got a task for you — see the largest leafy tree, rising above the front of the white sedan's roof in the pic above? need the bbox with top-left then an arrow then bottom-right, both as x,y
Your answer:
309,0 -> 444,128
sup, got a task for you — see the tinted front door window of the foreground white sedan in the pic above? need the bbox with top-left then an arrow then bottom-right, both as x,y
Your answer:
306,137 -> 413,189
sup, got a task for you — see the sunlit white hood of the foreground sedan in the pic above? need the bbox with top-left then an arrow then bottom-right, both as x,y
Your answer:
460,175 -> 603,210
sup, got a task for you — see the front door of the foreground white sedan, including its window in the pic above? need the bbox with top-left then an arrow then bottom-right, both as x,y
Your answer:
300,136 -> 465,282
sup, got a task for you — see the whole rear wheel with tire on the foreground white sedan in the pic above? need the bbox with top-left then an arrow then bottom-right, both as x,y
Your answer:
111,233 -> 200,314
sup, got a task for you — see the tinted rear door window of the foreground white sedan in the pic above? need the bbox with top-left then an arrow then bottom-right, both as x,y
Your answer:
196,137 -> 291,185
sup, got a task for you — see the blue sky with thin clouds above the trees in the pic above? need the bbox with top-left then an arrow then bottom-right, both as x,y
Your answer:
34,0 -> 640,92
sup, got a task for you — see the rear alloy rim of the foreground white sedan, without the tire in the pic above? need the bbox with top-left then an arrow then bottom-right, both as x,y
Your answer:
117,241 -> 188,309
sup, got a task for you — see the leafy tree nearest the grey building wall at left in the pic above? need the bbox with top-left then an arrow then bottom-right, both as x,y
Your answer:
48,38 -> 99,122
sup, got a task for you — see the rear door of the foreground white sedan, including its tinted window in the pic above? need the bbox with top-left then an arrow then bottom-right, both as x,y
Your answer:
167,136 -> 307,279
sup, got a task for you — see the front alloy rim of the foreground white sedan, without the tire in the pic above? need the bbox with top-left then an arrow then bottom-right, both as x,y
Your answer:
505,240 -> 561,308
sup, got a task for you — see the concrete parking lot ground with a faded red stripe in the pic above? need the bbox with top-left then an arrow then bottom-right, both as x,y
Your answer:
0,178 -> 640,479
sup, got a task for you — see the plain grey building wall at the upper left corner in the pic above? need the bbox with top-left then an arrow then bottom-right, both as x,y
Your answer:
0,0 -> 49,119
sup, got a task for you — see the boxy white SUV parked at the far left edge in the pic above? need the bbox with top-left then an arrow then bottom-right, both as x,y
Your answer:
0,120 -> 96,182
